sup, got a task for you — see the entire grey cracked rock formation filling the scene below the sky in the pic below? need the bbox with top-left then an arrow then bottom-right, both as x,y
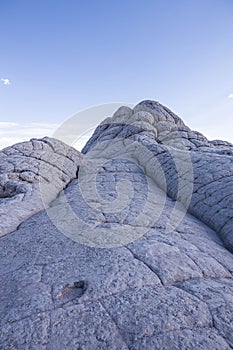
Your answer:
0,101 -> 233,350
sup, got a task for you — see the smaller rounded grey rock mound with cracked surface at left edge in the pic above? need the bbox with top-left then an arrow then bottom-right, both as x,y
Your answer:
0,137 -> 81,236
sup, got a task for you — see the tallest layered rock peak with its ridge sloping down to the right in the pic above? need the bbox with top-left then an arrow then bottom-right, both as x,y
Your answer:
83,101 -> 233,251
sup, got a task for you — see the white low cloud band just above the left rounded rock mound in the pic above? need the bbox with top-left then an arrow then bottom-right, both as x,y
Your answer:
0,122 -> 59,149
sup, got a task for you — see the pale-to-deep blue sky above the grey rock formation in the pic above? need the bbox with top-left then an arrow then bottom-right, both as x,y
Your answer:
0,0 -> 233,146
